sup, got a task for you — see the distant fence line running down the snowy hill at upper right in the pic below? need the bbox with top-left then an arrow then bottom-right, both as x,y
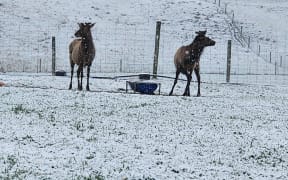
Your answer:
206,0 -> 288,72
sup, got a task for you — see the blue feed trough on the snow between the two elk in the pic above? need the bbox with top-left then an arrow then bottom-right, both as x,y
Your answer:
128,81 -> 159,94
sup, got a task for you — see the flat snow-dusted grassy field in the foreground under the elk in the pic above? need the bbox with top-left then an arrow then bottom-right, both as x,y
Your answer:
0,74 -> 288,179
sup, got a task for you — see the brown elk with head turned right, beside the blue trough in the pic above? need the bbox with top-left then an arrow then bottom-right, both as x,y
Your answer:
169,31 -> 216,96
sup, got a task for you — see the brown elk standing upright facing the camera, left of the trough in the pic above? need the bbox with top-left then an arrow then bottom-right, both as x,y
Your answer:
69,23 -> 96,91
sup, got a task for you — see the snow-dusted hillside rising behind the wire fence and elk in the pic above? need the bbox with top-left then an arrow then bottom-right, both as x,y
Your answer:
0,0 -> 287,74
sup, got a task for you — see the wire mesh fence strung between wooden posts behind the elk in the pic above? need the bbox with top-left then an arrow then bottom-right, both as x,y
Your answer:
0,18 -> 288,85
